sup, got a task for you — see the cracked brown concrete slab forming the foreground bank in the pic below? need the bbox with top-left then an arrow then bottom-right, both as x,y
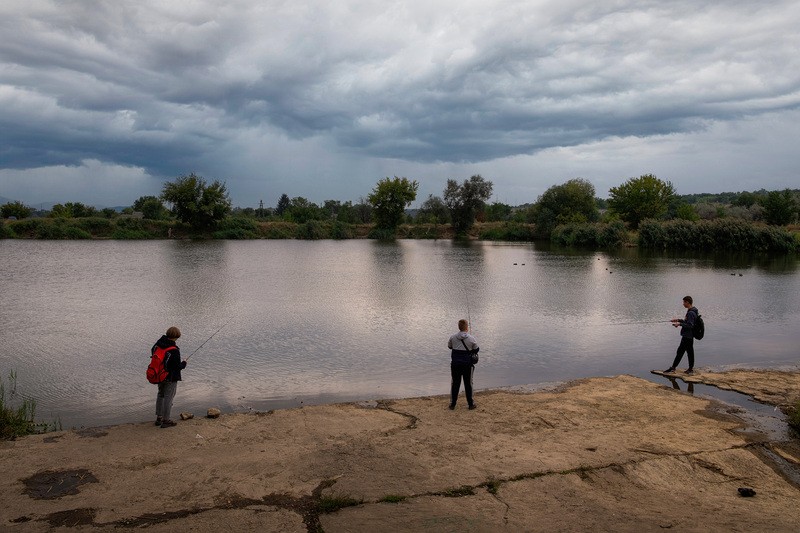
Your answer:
0,376 -> 800,532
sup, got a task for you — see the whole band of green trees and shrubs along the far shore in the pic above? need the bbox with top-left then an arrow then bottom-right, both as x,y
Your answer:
0,174 -> 800,253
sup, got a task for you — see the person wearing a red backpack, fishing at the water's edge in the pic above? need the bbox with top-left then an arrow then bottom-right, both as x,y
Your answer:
152,326 -> 186,428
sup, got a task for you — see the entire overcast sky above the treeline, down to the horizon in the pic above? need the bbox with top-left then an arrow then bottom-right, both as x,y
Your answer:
0,0 -> 800,207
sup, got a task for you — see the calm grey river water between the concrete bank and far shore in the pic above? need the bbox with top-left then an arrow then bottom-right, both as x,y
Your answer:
0,240 -> 800,428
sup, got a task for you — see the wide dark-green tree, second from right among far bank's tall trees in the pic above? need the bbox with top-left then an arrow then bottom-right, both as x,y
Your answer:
531,178 -> 600,237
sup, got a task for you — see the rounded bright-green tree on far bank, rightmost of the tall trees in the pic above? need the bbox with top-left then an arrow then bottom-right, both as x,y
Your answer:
608,174 -> 675,228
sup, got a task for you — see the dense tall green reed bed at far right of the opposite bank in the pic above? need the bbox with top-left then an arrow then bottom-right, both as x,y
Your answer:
638,219 -> 798,253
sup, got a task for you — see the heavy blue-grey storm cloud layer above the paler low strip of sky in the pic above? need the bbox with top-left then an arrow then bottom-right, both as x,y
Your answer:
0,0 -> 800,206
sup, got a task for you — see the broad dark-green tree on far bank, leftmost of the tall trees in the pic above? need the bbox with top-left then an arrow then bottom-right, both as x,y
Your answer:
161,173 -> 231,231
